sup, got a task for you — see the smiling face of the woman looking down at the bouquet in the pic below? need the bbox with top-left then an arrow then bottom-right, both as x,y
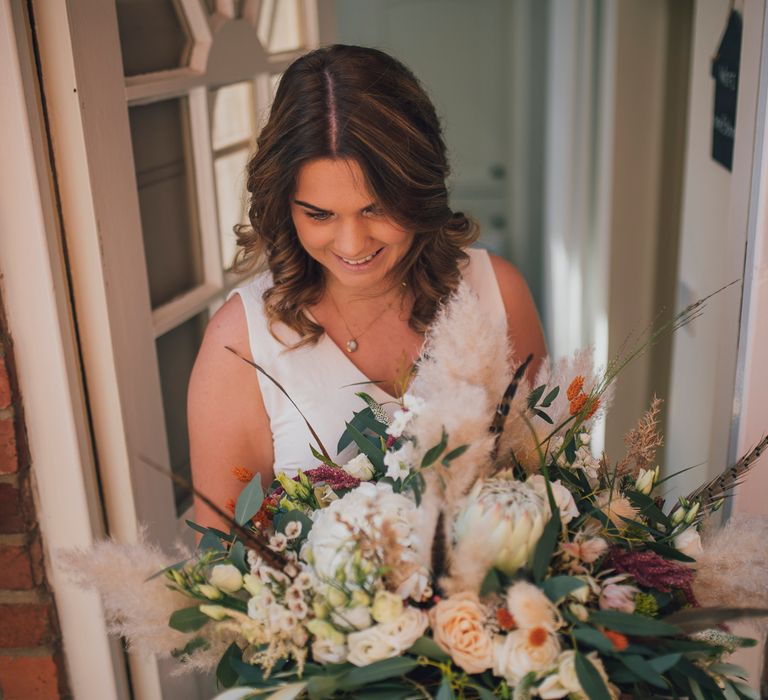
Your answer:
291,158 -> 413,290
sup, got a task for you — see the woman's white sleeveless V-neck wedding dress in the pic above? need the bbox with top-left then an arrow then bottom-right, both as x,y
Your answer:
230,243 -> 505,476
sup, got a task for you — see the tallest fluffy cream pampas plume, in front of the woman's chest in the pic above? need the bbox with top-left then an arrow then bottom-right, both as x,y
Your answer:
409,282 -> 512,408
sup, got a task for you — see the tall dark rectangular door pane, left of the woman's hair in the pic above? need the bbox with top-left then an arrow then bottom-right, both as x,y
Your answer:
130,98 -> 203,309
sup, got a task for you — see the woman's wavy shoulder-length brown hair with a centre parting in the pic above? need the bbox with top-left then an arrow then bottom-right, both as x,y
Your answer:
235,44 -> 478,347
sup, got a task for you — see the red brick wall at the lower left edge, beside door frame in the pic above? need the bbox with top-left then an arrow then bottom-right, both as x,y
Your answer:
0,299 -> 71,700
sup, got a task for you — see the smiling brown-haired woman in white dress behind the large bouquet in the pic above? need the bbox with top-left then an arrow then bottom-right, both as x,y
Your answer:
188,45 -> 546,526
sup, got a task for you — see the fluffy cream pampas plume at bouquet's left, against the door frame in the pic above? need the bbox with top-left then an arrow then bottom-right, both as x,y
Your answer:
55,531 -> 198,656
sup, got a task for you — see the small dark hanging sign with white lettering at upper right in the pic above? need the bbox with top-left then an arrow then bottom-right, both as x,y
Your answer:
712,10 -> 741,170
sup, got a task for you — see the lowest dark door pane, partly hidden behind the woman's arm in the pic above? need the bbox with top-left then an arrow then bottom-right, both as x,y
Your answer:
157,311 -> 208,516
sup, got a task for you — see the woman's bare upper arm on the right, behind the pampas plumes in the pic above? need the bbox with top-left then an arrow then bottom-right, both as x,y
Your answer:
490,255 -> 547,378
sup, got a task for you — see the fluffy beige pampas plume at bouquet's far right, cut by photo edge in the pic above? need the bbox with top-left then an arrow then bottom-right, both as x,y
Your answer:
693,516 -> 768,632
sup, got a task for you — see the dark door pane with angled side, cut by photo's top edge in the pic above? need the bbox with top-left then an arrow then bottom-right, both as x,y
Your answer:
117,0 -> 192,76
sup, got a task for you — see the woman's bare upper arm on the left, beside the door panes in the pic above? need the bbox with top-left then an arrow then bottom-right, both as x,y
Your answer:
187,295 -> 273,529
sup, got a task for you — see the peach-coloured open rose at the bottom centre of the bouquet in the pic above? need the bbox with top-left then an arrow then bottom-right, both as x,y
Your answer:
429,593 -> 493,673
